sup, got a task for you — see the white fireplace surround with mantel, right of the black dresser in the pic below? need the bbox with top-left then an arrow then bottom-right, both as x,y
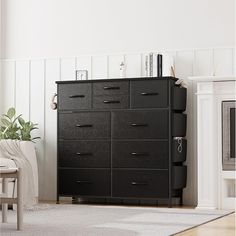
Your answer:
189,76 -> 236,209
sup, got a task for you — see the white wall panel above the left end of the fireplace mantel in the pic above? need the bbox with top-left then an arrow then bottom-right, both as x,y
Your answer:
194,49 -> 214,76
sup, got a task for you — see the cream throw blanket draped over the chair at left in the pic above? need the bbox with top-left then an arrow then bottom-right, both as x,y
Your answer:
0,139 -> 36,208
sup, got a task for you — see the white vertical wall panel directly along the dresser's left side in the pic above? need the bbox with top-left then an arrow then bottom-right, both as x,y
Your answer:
42,59 -> 60,200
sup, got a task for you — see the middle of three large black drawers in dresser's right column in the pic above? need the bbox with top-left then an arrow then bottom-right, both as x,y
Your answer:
112,141 -> 169,169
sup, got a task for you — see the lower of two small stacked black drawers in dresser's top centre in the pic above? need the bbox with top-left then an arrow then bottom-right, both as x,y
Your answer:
93,95 -> 129,109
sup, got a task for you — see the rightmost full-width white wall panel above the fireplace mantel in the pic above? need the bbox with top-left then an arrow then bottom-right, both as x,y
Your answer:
213,48 -> 233,76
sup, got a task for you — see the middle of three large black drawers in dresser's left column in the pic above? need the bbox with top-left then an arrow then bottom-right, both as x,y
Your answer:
58,141 -> 110,168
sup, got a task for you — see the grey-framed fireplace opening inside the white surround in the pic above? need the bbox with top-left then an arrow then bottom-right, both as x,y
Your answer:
222,101 -> 236,170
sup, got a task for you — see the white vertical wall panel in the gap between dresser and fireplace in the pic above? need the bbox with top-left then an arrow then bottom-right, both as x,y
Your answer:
175,51 -> 197,205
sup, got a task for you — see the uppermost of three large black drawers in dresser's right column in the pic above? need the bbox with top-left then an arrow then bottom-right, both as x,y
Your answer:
112,110 -> 168,139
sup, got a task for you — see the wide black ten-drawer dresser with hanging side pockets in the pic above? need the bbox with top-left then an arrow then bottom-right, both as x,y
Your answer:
56,77 -> 187,206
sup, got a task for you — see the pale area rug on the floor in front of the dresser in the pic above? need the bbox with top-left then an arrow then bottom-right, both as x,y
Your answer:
0,204 -> 232,236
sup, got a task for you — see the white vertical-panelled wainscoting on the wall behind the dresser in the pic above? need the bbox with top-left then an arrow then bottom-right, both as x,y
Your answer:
1,47 -> 235,205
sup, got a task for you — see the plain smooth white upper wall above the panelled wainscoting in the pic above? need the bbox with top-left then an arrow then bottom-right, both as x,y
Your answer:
0,0 -> 235,59
